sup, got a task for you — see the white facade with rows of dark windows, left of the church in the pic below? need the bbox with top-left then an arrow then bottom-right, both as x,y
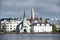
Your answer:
1,20 -> 21,31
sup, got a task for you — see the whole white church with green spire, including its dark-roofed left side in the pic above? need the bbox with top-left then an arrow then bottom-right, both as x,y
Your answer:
17,11 -> 31,33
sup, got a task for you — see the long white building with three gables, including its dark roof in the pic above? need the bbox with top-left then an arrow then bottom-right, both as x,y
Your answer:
32,20 -> 52,33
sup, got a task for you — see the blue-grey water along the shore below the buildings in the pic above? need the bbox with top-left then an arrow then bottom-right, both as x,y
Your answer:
0,34 -> 60,40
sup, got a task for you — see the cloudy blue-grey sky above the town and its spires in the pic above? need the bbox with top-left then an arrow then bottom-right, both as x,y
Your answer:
0,0 -> 60,18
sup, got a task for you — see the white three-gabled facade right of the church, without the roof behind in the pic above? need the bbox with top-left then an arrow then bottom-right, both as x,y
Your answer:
33,24 -> 52,32
